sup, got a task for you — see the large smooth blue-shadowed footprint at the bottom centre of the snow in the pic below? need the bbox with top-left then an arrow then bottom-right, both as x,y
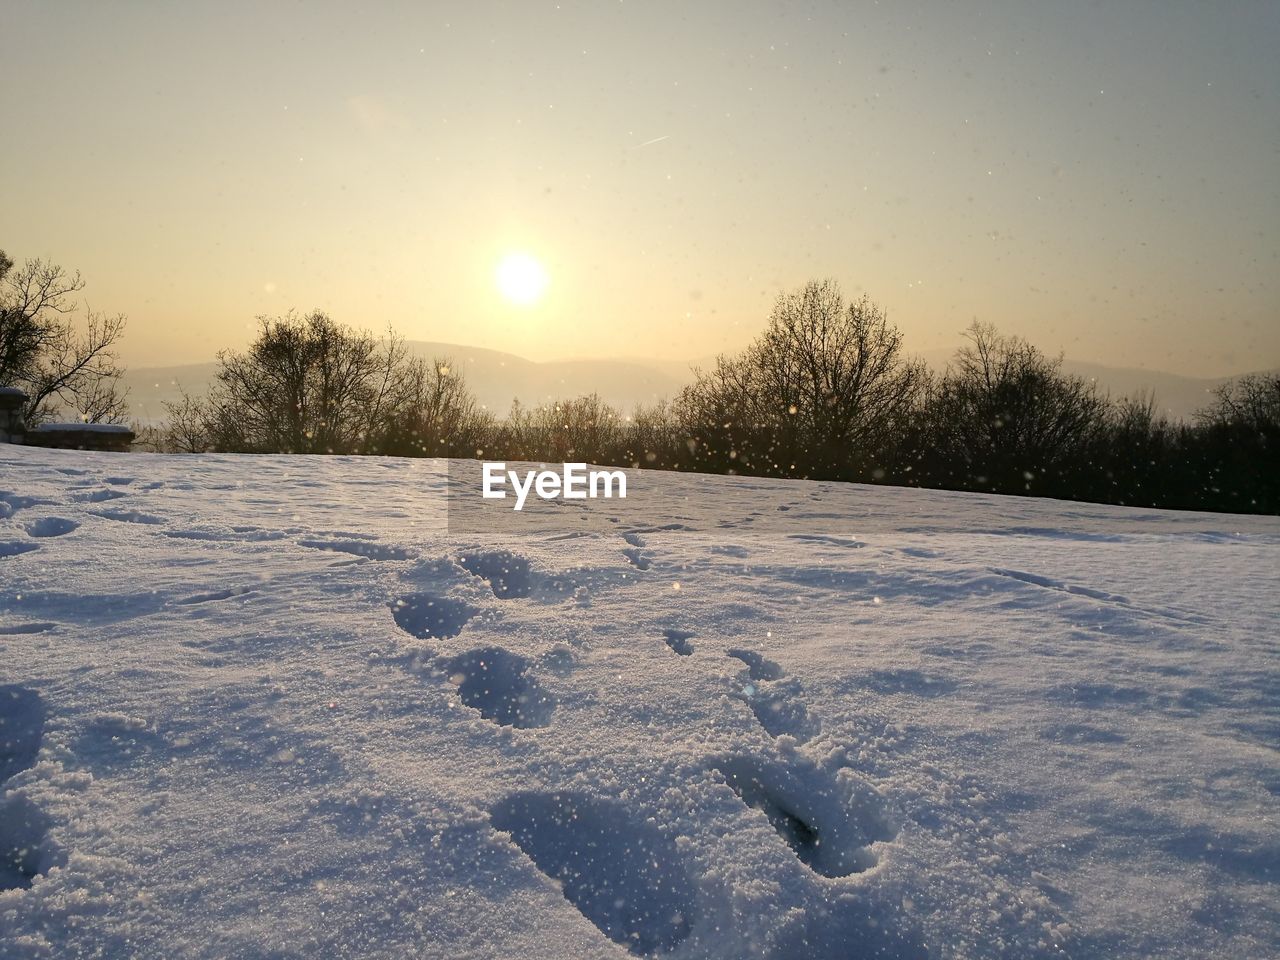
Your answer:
489,792 -> 695,956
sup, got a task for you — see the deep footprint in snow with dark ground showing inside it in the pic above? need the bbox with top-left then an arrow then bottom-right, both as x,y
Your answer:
713,756 -> 897,877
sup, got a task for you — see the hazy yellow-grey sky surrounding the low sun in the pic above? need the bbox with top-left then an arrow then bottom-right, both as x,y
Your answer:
0,0 -> 1280,375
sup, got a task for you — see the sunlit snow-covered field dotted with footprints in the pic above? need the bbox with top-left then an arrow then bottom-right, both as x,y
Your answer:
0,447 -> 1280,960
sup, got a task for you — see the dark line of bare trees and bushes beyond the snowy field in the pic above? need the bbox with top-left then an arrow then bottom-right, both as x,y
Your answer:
145,282 -> 1280,513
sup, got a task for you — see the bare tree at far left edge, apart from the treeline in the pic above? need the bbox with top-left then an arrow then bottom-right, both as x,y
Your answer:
0,251 -> 128,424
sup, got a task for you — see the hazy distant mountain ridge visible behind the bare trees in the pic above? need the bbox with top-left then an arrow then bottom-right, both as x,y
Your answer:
125,340 -> 1269,422
